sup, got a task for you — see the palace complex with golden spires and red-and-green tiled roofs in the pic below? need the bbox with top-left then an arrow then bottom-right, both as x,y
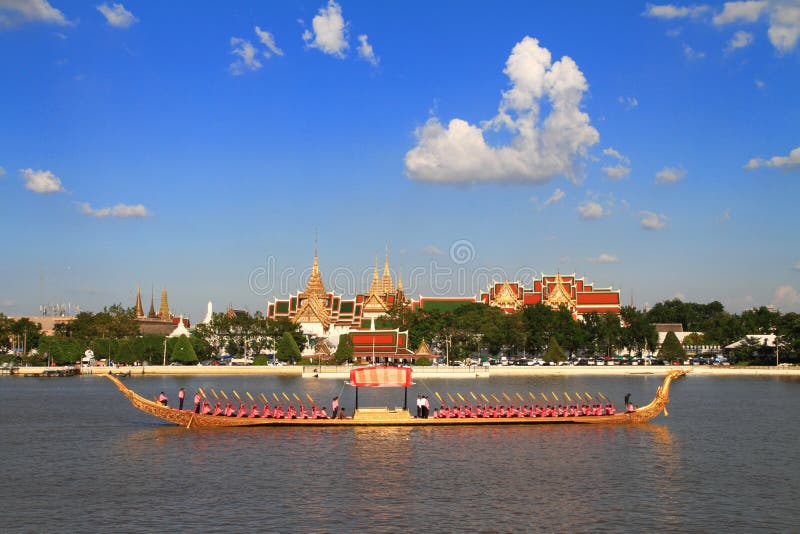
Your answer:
267,247 -> 620,362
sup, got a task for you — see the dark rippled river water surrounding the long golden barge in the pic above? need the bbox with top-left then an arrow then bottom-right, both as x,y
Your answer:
0,375 -> 800,532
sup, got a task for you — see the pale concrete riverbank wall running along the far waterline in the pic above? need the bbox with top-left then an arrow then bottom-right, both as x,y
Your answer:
7,365 -> 800,380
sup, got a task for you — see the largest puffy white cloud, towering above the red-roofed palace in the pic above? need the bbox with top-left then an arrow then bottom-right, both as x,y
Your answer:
405,37 -> 599,184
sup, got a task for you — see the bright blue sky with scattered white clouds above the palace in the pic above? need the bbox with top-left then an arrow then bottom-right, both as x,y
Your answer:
0,0 -> 800,322
